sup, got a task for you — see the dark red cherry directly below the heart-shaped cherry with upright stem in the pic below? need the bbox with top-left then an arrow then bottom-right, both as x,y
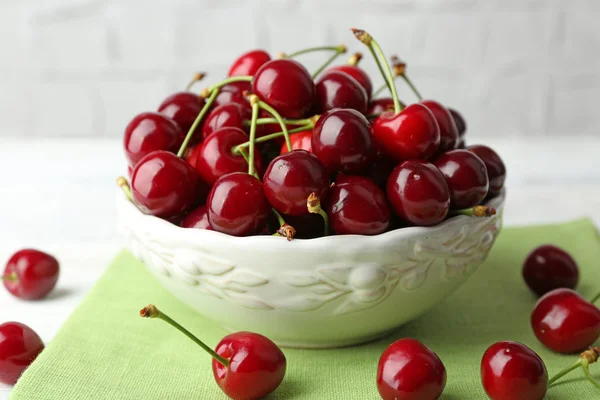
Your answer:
386,160 -> 450,226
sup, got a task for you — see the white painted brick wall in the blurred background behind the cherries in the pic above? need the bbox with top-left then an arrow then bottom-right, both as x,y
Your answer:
0,0 -> 600,137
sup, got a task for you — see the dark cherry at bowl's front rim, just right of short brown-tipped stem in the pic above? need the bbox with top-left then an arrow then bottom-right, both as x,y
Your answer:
327,176 -> 391,235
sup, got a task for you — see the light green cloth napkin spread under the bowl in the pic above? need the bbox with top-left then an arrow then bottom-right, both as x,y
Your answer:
11,220 -> 600,400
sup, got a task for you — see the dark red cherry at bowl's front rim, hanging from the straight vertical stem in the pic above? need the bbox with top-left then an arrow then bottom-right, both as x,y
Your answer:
206,172 -> 271,236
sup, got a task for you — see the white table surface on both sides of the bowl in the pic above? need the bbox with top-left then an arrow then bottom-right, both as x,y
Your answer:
0,137 -> 600,400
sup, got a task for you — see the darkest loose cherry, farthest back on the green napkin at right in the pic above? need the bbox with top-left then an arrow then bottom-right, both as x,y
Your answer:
523,245 -> 579,296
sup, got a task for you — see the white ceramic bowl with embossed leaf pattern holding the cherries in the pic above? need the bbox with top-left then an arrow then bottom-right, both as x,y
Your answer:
118,194 -> 504,348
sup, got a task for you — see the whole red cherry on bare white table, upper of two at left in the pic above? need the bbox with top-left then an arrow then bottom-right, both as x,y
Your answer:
3,249 -> 60,300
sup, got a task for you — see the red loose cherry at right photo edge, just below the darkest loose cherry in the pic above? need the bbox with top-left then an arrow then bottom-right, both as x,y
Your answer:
531,289 -> 600,354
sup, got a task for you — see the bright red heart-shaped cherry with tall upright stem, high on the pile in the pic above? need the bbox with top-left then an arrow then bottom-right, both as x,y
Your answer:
373,104 -> 440,161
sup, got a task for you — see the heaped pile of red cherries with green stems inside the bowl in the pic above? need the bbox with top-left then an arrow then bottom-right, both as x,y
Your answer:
118,30 -> 506,239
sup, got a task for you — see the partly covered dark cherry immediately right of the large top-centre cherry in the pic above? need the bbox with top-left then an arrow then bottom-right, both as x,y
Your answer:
317,71 -> 369,114
